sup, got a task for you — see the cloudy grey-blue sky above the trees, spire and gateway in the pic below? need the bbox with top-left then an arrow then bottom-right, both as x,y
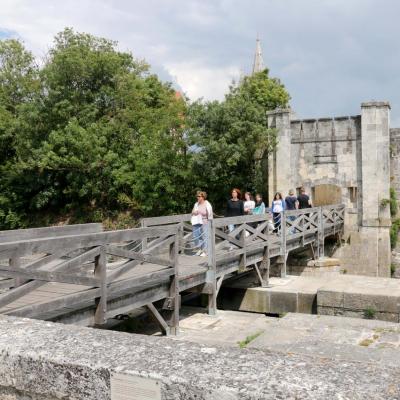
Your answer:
0,0 -> 400,126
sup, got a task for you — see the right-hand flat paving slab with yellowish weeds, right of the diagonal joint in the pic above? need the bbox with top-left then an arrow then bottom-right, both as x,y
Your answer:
248,314 -> 400,366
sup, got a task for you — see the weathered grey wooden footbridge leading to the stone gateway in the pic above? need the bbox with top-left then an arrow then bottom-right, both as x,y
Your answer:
0,205 -> 345,334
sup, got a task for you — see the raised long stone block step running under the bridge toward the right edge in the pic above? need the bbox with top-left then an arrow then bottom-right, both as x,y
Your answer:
220,275 -> 400,322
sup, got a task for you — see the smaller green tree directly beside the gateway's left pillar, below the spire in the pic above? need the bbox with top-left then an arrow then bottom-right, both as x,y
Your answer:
189,70 -> 290,209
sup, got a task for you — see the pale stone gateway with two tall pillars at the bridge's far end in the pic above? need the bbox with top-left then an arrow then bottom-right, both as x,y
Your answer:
267,101 -> 392,277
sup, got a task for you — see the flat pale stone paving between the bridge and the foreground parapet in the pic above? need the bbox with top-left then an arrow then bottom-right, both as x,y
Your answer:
175,309 -> 400,367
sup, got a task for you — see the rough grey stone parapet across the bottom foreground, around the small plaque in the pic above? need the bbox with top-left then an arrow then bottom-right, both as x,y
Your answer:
0,316 -> 400,400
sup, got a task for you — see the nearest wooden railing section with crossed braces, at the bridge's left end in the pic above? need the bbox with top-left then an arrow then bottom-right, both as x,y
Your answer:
0,226 -> 180,333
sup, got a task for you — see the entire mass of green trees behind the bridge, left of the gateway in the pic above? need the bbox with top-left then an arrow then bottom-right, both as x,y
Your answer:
0,28 -> 289,229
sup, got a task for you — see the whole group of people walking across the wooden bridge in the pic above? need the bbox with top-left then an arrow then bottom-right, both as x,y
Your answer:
191,187 -> 312,257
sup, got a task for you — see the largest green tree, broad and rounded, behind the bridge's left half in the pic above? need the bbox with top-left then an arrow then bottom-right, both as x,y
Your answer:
0,29 -> 191,227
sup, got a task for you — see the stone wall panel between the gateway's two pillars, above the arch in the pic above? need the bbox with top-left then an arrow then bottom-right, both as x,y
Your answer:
291,116 -> 361,210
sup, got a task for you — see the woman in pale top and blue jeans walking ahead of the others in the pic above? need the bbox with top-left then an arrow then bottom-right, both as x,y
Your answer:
192,191 -> 213,257
